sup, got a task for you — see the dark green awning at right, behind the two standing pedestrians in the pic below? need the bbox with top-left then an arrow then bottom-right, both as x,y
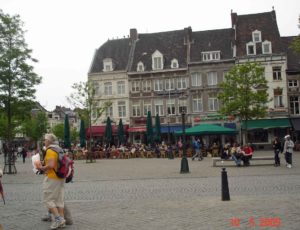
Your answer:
242,118 -> 292,129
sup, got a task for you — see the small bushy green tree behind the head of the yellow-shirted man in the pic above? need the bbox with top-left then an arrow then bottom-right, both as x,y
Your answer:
23,112 -> 48,148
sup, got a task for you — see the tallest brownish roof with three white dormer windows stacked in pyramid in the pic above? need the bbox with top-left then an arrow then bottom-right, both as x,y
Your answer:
231,10 -> 283,57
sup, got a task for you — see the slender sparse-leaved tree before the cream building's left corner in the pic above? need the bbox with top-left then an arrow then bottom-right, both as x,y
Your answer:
67,81 -> 112,154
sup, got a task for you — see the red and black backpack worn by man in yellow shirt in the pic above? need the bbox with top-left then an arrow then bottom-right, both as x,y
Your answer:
48,146 -> 74,183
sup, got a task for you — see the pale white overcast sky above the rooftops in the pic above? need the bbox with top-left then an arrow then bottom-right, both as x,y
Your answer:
0,0 -> 300,111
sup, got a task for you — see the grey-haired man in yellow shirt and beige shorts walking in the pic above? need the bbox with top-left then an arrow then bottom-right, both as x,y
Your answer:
38,134 -> 66,229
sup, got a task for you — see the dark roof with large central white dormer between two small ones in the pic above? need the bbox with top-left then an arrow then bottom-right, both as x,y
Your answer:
130,30 -> 187,72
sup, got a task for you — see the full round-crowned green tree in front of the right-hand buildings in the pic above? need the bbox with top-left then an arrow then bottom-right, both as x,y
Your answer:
218,62 -> 269,143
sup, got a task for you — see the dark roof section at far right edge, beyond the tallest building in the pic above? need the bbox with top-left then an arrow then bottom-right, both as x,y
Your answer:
281,36 -> 300,73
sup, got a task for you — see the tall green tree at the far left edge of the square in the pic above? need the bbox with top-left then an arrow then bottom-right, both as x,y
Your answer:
0,10 -> 41,174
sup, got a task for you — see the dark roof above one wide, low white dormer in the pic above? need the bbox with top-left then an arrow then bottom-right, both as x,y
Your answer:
190,29 -> 234,62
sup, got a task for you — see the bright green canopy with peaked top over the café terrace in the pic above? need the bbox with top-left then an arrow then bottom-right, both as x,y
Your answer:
175,124 -> 237,135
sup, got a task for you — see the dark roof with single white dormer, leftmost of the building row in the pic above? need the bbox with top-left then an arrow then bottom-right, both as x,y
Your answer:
89,38 -> 132,73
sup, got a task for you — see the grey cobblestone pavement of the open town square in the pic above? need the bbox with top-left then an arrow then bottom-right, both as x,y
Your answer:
0,151 -> 300,230
